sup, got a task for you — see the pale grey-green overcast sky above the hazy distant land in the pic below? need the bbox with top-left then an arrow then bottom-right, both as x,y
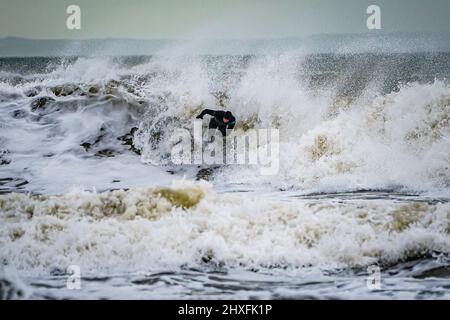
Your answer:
0,0 -> 450,39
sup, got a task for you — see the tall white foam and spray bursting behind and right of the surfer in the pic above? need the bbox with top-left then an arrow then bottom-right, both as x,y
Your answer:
127,55 -> 450,191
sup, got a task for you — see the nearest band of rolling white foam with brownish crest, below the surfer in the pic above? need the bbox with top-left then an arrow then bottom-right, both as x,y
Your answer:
0,181 -> 450,275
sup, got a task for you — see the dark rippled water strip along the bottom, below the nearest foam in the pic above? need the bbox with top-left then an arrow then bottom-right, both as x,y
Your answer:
21,259 -> 450,299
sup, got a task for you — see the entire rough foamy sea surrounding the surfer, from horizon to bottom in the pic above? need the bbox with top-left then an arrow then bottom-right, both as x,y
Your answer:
0,53 -> 450,299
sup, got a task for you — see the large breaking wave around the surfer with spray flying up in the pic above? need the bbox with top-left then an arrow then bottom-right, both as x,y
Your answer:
0,54 -> 450,192
